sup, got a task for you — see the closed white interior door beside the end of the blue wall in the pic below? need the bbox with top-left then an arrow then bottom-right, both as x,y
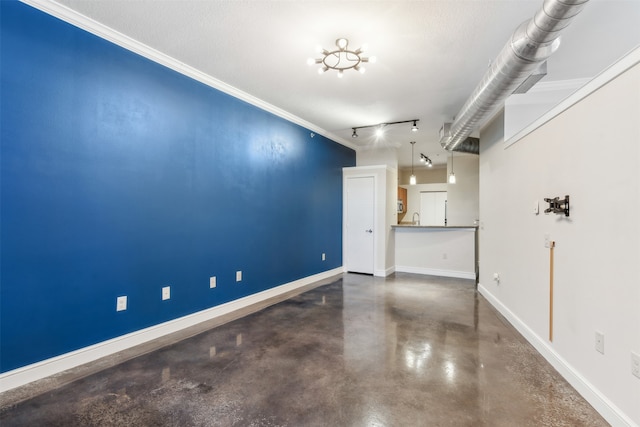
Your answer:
345,176 -> 375,274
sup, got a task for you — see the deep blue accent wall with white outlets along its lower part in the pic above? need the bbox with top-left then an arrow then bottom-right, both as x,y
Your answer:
0,1 -> 355,372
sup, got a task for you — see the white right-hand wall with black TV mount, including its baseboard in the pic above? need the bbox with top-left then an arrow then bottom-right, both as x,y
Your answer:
480,54 -> 640,425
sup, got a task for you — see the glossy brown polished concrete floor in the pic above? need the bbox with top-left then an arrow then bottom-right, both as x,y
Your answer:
0,273 -> 607,427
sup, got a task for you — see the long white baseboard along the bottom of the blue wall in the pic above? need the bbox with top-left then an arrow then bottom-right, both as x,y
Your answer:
0,267 -> 343,393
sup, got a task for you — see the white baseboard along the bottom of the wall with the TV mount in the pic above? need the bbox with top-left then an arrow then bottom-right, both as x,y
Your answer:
478,284 -> 639,427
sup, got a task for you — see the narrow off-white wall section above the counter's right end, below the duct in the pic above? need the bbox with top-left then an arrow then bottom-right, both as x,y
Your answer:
447,153 -> 480,226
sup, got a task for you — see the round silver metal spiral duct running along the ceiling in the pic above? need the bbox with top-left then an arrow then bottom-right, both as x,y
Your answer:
440,0 -> 589,152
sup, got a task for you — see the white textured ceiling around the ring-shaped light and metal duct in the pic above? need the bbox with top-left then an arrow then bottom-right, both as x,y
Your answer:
43,0 -> 640,167
